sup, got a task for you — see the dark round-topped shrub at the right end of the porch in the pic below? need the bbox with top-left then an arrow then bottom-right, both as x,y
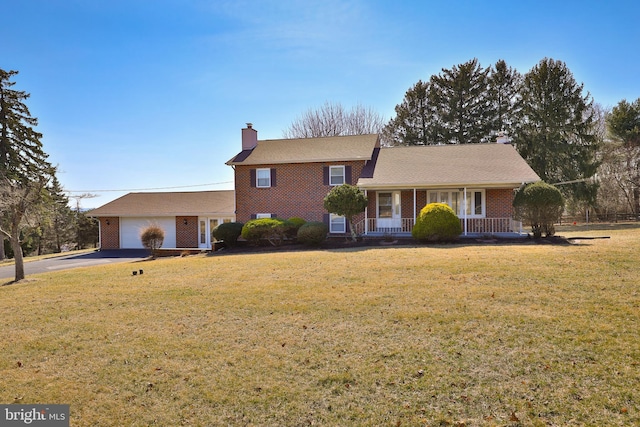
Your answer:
513,181 -> 564,238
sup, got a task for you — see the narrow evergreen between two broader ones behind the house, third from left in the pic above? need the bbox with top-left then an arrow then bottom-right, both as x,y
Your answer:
488,59 -> 522,136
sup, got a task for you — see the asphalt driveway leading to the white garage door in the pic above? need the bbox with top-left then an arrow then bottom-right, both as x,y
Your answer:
0,249 -> 149,281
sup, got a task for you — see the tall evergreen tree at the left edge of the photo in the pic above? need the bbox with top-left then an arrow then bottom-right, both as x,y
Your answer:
0,69 -> 55,281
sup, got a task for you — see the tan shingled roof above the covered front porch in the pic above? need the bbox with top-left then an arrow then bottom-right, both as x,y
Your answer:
358,144 -> 540,189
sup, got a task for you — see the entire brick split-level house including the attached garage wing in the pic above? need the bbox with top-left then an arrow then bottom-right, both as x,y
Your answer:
89,124 -> 540,249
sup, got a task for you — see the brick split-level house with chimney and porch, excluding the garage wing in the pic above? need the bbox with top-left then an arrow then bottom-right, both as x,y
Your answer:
227,124 -> 540,236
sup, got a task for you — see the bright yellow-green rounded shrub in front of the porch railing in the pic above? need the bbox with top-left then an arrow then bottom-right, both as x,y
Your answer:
411,203 -> 462,242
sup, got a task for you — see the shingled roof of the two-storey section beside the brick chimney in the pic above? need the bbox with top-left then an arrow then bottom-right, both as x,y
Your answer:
226,134 -> 380,165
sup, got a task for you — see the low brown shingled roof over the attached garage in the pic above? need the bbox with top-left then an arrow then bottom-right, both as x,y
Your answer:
87,190 -> 235,217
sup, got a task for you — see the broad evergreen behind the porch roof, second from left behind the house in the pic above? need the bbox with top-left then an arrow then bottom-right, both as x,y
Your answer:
431,58 -> 491,144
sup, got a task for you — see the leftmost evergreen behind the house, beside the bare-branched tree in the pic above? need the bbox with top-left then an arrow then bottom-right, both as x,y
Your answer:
383,80 -> 439,145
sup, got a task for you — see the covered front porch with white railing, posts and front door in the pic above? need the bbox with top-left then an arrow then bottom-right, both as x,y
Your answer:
354,187 -> 523,237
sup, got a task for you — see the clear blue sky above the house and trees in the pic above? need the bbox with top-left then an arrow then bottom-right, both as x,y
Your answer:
0,0 -> 640,208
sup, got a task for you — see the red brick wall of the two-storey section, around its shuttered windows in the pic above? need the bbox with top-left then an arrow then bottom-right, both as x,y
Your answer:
235,161 -> 365,222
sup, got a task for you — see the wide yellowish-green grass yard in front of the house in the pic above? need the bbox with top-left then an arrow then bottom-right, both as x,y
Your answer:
0,227 -> 640,426
